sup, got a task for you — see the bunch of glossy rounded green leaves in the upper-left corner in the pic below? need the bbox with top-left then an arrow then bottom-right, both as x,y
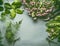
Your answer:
0,0 -> 23,20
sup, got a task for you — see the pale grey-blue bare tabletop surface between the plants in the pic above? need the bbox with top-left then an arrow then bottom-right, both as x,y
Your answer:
16,11 -> 48,46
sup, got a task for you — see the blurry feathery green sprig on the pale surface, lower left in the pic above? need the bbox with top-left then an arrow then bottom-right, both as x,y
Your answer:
5,21 -> 22,46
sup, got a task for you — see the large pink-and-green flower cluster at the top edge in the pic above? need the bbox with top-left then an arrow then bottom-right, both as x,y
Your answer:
23,0 -> 54,20
